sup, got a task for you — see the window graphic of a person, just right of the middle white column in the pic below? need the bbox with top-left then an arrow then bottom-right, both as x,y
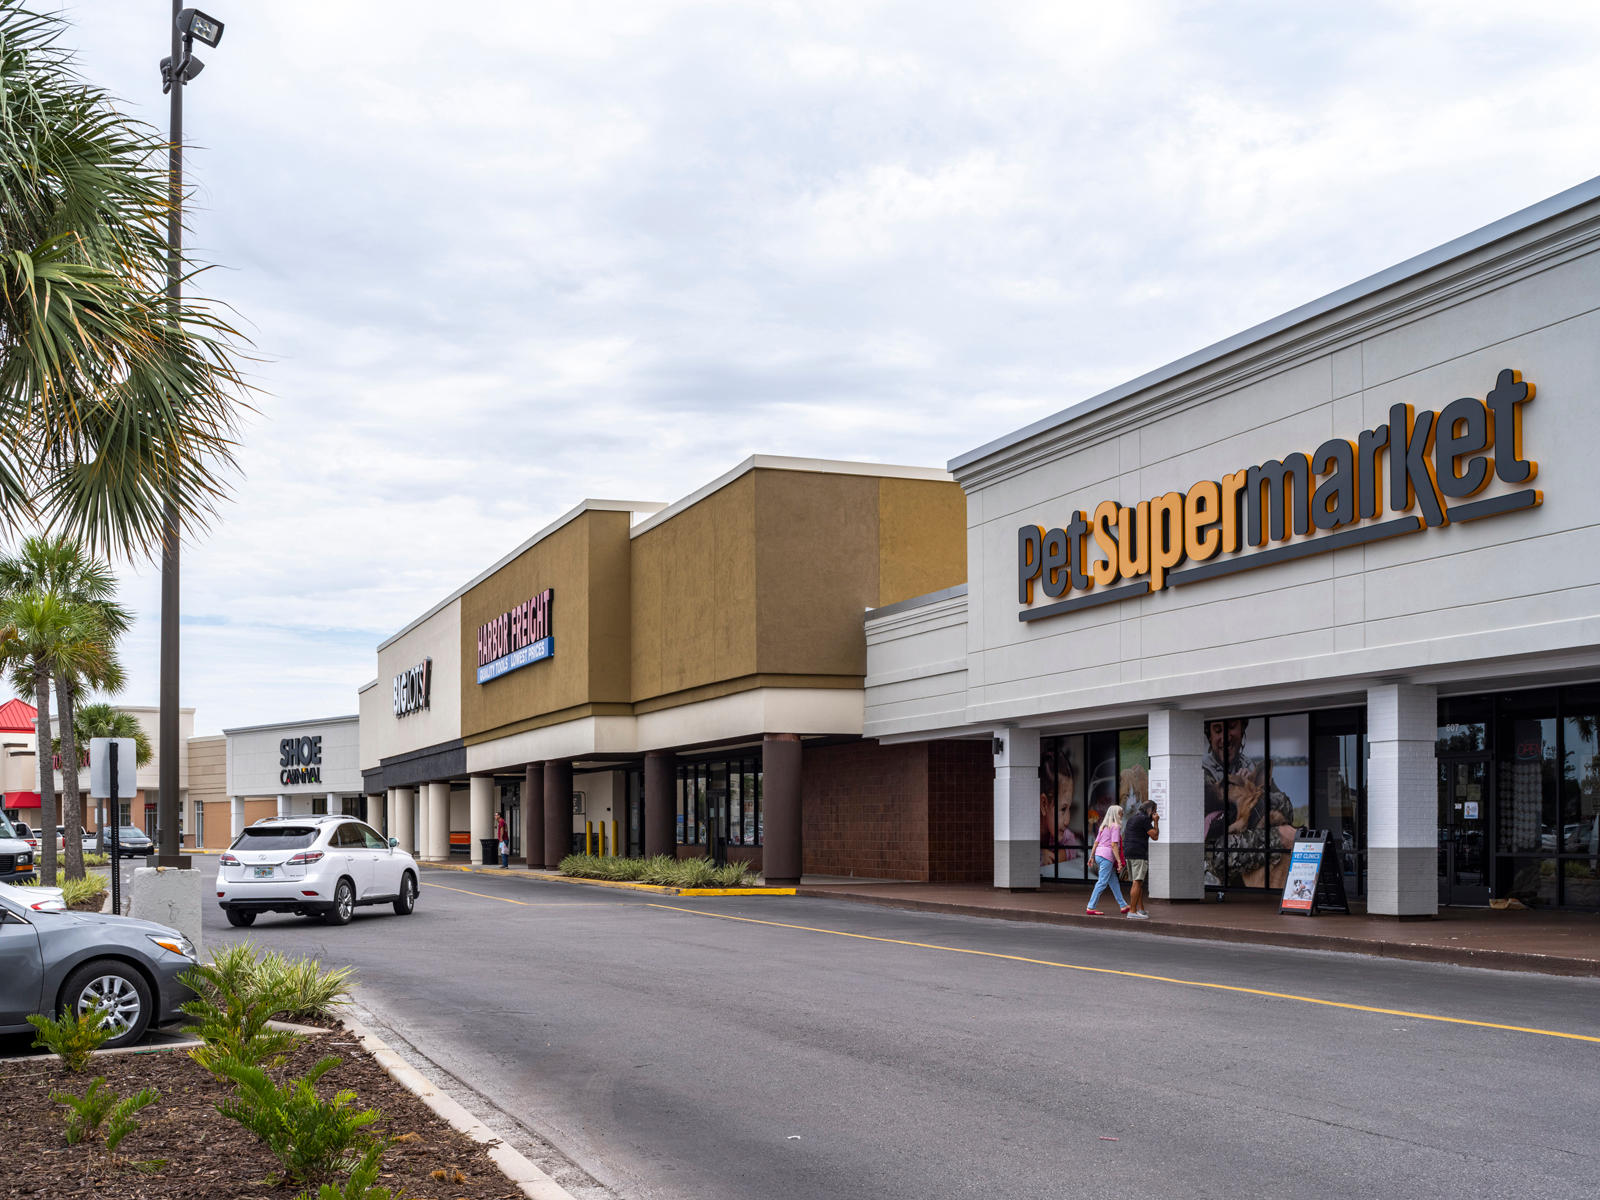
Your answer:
1200,717 -> 1294,888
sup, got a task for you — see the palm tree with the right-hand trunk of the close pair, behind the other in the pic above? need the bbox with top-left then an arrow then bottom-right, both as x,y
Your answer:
0,536 -> 133,878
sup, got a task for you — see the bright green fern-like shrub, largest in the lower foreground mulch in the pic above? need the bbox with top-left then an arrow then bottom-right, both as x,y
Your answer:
216,1058 -> 378,1195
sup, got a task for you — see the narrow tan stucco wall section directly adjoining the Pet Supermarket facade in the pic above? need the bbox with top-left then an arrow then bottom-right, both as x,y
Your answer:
877,478 -> 966,606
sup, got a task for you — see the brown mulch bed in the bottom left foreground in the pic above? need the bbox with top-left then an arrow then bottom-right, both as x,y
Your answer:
0,1032 -> 523,1200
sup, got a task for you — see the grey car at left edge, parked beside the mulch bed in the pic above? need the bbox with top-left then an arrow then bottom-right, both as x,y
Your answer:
0,888 -> 195,1046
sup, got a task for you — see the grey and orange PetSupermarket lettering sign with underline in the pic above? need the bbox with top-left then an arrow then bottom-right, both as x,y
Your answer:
1016,370 -> 1544,621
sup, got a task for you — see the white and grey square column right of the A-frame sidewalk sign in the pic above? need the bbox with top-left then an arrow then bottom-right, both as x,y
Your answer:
1366,683 -> 1438,917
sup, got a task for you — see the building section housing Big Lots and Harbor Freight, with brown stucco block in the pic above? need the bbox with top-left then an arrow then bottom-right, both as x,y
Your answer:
360,458 -> 992,880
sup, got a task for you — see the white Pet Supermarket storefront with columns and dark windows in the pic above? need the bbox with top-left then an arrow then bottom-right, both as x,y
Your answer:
864,181 -> 1600,915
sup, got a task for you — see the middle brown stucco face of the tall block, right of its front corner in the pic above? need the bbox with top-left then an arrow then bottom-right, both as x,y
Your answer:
754,470 -> 878,675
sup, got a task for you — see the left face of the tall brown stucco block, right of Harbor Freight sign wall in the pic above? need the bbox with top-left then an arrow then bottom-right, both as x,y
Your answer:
632,474 -> 755,699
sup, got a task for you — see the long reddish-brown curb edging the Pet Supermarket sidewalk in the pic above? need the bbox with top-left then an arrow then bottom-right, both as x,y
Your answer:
795,886 -> 1600,978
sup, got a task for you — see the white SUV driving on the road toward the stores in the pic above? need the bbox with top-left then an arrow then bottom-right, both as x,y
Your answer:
216,816 -> 418,925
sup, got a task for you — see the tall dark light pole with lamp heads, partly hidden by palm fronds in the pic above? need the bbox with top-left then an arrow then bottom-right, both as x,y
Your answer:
151,0 -> 222,867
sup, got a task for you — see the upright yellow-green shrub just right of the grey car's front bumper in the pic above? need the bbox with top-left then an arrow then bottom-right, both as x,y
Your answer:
181,942 -> 301,1078
